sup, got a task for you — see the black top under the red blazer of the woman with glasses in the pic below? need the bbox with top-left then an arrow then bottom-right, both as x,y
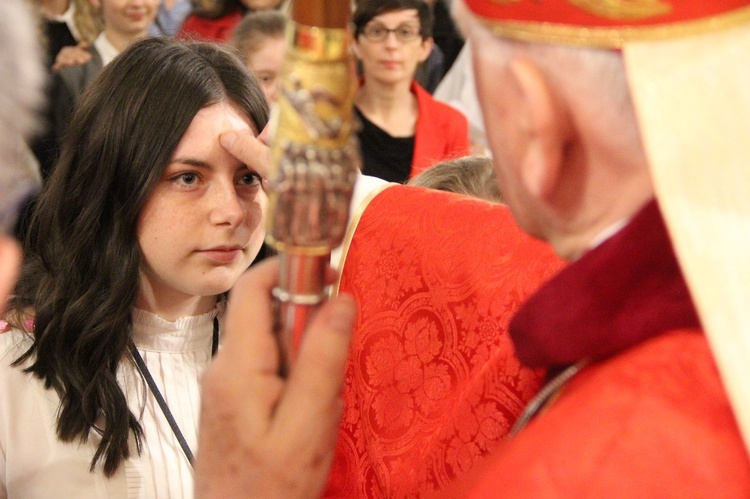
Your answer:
354,107 -> 414,183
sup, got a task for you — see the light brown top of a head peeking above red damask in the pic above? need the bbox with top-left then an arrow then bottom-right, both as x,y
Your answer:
408,156 -> 503,203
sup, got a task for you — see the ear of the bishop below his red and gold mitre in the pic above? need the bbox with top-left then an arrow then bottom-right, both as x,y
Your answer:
509,57 -> 572,199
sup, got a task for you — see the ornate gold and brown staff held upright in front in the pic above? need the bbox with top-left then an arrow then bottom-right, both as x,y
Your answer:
266,0 -> 360,371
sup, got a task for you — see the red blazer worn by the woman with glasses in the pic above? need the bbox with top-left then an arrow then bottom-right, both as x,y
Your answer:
411,82 -> 470,177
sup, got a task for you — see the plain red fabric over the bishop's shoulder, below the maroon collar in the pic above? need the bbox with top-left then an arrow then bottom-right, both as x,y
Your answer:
442,331 -> 750,499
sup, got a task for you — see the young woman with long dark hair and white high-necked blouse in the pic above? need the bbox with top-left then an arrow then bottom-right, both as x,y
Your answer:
0,37 -> 268,498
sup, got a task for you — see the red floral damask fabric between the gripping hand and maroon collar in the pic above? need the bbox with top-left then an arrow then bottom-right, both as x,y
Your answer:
326,186 -> 562,498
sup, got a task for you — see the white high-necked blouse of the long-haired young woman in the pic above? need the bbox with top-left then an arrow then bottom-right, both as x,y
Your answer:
0,309 -> 219,498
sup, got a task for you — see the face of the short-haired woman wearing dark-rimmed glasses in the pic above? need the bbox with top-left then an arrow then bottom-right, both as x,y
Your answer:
353,9 -> 433,84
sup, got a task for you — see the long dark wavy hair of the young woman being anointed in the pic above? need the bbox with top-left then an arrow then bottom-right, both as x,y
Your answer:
8,38 -> 268,476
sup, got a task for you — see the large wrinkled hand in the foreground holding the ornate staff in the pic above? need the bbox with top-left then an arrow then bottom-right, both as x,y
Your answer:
195,252 -> 355,498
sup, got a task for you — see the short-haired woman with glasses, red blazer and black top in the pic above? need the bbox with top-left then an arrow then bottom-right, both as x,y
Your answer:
353,0 -> 469,182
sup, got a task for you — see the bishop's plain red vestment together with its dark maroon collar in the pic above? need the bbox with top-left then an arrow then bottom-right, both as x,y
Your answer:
445,202 -> 750,498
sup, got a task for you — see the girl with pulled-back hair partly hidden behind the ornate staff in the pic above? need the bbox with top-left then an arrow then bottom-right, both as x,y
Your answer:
229,10 -> 288,104
